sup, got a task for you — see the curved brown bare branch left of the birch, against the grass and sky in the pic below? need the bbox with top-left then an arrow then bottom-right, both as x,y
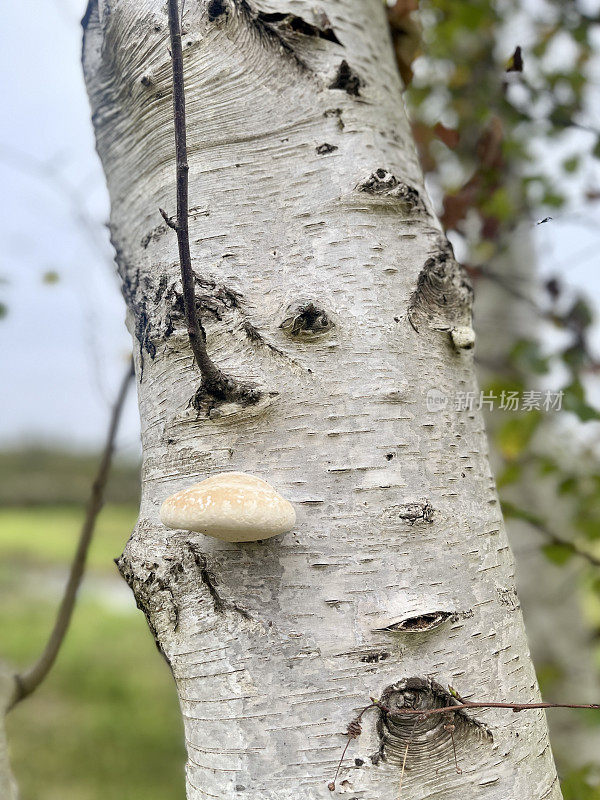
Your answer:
11,359 -> 133,708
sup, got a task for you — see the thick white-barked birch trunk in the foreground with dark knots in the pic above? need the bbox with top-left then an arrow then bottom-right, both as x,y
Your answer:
84,0 -> 561,800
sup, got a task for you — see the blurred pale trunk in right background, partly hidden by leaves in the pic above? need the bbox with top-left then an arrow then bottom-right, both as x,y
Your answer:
474,223 -> 600,769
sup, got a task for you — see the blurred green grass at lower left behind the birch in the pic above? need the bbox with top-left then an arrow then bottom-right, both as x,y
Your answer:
0,505 -> 185,800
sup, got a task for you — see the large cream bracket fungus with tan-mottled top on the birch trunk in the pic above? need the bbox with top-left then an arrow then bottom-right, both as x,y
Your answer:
160,472 -> 296,542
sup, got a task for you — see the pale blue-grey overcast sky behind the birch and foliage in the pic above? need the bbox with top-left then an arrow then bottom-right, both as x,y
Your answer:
0,0 -> 600,452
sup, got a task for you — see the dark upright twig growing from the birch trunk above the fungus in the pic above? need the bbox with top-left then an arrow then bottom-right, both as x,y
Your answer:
164,0 -> 259,402
